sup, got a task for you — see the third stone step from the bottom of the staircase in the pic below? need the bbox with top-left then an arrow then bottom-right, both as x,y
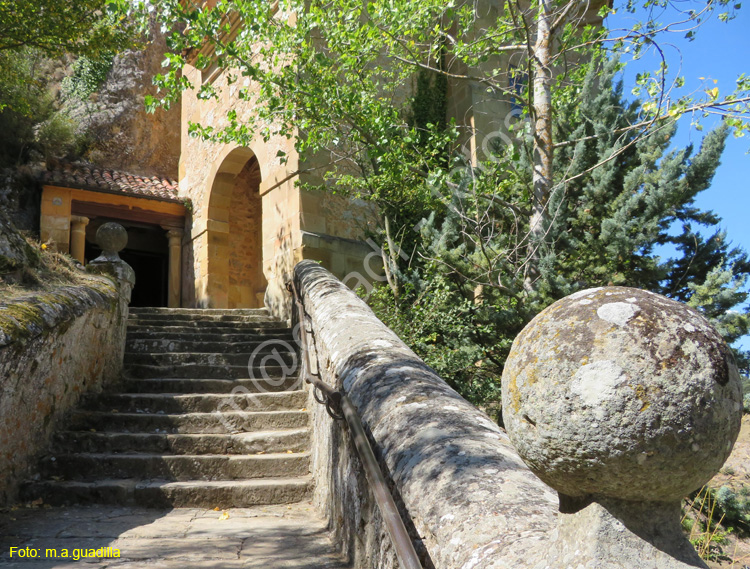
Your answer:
53,428 -> 310,455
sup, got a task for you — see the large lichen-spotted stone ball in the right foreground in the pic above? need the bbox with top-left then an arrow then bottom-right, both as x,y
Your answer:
503,287 -> 742,501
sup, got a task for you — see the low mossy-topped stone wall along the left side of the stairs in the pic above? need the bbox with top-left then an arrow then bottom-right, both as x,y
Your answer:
0,276 -> 127,505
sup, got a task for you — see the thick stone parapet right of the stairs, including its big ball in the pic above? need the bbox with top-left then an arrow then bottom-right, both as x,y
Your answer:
295,261 -> 741,569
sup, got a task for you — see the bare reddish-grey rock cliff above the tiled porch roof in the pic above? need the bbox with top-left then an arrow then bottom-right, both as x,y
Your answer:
74,25 -> 180,179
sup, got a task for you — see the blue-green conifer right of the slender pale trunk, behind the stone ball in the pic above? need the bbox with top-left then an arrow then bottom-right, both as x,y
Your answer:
550,60 -> 750,350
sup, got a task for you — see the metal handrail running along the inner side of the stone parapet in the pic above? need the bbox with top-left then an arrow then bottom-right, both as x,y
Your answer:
287,280 -> 423,569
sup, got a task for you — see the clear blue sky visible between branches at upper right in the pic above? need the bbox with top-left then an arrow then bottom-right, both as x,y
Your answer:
607,2 -> 750,349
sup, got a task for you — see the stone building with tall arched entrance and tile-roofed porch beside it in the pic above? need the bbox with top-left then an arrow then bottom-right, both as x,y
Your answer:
41,3 -> 604,316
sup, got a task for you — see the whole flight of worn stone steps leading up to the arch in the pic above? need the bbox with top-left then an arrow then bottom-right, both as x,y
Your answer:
23,308 -> 311,508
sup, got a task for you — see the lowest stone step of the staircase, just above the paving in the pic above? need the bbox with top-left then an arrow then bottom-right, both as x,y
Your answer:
22,476 -> 312,508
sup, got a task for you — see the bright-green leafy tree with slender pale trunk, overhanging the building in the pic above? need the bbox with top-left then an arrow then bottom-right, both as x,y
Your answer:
141,0 -> 750,229
